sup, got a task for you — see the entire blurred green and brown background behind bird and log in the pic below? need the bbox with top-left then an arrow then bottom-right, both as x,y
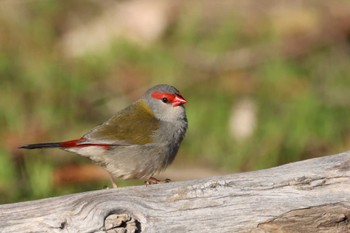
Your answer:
0,0 -> 350,203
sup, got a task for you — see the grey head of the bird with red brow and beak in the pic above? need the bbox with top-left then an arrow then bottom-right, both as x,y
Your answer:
143,84 -> 186,122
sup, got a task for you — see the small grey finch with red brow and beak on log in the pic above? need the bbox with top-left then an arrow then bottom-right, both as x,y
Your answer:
20,84 -> 187,187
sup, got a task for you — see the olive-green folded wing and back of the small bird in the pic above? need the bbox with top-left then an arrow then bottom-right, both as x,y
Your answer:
83,100 -> 159,145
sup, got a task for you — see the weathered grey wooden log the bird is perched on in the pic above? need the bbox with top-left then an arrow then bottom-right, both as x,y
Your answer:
0,152 -> 350,233
